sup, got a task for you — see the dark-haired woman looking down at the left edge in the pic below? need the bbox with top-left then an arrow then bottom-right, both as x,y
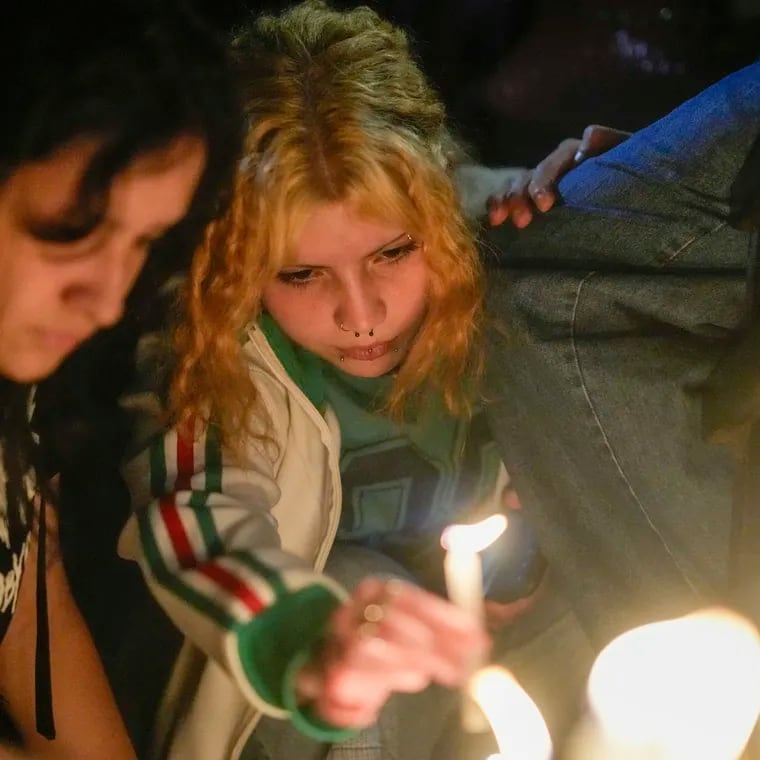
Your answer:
0,0 -> 239,760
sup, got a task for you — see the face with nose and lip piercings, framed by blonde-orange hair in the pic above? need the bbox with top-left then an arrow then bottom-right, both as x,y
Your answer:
264,203 -> 428,377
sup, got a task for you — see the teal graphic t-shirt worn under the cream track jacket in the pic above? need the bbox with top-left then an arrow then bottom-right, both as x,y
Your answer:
323,363 -> 504,592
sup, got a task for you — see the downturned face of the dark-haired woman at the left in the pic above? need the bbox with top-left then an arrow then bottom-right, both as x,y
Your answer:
0,137 -> 205,382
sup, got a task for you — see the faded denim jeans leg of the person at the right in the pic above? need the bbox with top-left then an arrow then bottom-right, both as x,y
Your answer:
488,65 -> 760,645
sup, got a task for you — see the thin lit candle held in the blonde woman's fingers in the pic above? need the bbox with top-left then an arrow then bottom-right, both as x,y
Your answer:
441,515 -> 507,733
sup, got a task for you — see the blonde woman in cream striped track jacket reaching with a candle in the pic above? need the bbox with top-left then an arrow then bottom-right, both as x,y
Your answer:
122,2 -> 556,760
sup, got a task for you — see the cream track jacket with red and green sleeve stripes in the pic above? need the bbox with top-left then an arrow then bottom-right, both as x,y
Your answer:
119,327 -> 345,760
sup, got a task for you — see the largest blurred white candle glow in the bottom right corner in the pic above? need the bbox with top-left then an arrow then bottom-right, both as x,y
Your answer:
588,609 -> 760,760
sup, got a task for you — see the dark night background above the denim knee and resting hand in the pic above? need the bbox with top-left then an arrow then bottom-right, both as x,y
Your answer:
203,0 -> 760,165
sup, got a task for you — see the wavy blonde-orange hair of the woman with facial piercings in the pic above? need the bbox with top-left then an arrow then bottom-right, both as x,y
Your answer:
172,1 -> 482,445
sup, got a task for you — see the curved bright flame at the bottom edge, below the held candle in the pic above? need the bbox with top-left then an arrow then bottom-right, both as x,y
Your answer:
470,666 -> 552,760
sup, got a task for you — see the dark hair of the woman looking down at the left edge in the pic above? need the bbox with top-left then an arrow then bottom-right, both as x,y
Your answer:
0,0 -> 242,540
